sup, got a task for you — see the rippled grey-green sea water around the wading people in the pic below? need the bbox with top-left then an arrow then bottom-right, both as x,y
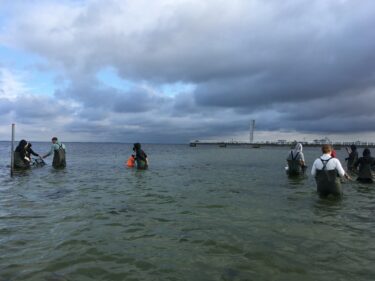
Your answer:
0,142 -> 375,281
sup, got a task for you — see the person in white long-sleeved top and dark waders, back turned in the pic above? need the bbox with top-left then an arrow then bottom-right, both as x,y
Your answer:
311,144 -> 351,197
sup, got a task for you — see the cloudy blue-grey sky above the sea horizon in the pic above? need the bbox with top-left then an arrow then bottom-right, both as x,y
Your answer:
0,0 -> 375,143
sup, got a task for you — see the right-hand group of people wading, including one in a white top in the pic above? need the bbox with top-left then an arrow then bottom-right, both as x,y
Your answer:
286,143 -> 375,197
